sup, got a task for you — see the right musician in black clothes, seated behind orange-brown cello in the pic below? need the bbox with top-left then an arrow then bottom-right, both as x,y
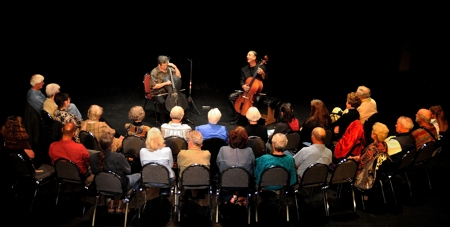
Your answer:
229,50 -> 268,124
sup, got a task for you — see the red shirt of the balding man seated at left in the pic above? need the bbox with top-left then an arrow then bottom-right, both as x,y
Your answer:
48,140 -> 90,174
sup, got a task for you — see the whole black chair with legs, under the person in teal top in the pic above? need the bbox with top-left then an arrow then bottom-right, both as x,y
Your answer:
255,166 -> 290,222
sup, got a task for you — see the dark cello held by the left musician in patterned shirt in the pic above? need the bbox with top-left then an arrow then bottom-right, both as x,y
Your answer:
164,63 -> 189,112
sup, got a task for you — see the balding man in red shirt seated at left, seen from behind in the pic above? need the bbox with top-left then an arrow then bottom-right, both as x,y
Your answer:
48,122 -> 94,184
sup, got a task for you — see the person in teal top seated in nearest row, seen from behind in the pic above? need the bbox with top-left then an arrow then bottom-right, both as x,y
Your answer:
254,133 -> 297,190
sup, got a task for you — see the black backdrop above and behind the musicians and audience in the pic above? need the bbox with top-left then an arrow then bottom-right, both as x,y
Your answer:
1,2 -> 448,119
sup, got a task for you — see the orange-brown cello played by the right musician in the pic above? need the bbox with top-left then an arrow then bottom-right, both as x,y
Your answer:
234,55 -> 268,116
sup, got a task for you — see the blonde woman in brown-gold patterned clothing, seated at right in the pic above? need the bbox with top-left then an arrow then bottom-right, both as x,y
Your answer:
348,122 -> 389,175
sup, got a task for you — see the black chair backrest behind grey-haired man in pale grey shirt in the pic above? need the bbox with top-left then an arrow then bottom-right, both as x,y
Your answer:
299,163 -> 328,187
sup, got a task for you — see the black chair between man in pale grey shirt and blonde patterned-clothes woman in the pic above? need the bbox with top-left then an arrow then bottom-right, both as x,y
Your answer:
324,159 -> 358,215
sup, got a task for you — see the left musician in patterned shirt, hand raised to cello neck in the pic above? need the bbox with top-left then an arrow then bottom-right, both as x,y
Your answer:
150,55 -> 193,123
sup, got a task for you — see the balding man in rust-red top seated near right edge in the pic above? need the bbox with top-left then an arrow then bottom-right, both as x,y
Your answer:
412,109 -> 438,150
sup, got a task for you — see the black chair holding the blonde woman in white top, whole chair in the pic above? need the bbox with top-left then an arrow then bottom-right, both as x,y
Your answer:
139,162 -> 176,220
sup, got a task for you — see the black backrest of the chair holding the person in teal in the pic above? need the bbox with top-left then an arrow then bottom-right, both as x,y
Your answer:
258,166 -> 290,189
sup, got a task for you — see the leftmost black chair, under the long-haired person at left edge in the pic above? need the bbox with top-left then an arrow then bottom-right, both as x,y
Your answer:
9,149 -> 56,211
